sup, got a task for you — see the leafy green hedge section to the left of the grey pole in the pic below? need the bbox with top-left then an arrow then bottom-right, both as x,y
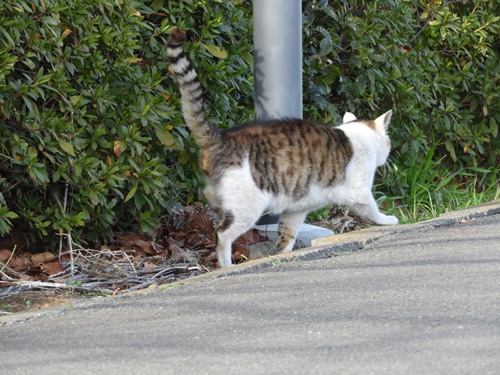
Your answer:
0,0 -> 252,245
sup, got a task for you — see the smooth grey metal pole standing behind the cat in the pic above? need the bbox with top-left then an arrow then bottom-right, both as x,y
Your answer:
253,0 -> 302,225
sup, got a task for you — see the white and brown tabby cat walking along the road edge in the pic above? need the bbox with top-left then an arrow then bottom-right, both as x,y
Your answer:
167,28 -> 398,267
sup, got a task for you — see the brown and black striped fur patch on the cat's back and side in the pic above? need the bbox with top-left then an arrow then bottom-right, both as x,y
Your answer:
217,119 -> 353,198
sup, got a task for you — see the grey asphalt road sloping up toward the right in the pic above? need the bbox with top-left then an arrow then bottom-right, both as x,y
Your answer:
0,210 -> 500,375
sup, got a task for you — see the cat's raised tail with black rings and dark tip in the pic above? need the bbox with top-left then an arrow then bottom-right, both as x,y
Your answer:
167,28 -> 220,148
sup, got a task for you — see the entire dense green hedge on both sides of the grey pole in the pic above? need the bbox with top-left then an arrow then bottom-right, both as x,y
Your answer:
0,0 -> 500,245
